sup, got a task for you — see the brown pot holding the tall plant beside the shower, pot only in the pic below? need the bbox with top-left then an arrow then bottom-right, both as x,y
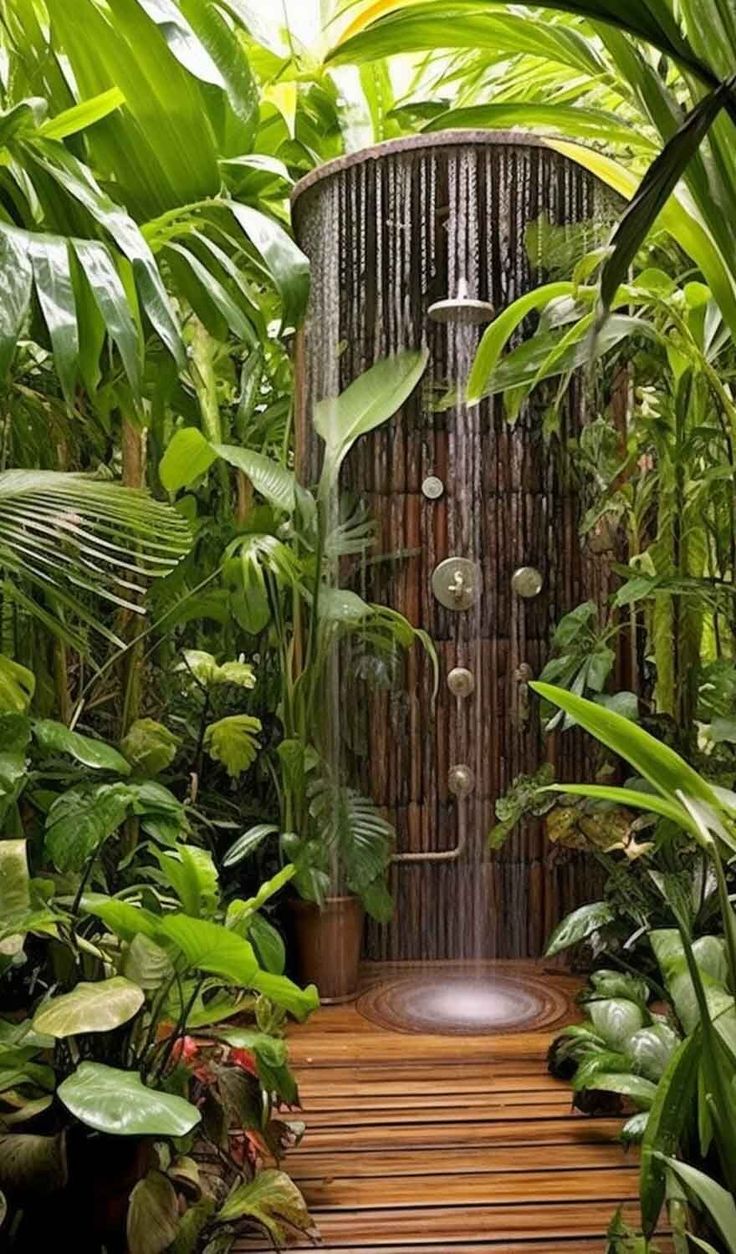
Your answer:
290,897 -> 364,1004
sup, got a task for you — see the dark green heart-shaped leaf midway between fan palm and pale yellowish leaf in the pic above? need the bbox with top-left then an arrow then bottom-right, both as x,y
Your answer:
45,784 -> 134,872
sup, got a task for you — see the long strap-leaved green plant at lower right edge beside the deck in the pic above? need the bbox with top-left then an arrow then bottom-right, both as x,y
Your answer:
534,683 -> 736,1244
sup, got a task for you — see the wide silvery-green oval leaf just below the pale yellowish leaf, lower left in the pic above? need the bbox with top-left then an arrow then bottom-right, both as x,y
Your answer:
56,1062 -> 201,1136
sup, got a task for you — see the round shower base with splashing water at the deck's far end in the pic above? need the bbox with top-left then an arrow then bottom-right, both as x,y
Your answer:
356,972 -> 569,1036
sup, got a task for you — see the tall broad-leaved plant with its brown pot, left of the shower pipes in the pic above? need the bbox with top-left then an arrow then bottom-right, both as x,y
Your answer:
181,352 -> 436,1001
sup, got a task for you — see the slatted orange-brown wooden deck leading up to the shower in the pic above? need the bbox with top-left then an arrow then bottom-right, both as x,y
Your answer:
237,963 -> 665,1254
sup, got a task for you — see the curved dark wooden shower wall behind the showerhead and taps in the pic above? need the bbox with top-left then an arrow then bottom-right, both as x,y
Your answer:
293,132 -> 621,961
